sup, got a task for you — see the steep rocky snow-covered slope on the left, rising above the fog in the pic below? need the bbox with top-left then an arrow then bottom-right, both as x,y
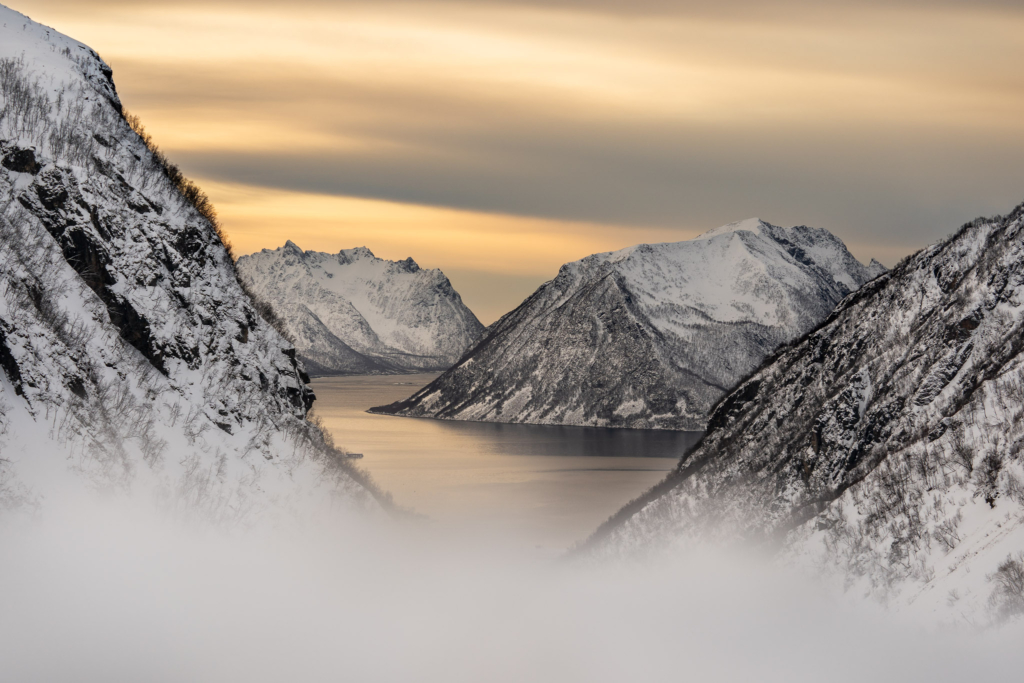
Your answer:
0,6 -> 375,520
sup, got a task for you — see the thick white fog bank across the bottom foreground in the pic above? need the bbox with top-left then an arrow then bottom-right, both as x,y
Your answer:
0,497 -> 1024,683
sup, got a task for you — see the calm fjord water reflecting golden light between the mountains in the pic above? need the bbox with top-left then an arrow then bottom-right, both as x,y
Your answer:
313,374 -> 699,550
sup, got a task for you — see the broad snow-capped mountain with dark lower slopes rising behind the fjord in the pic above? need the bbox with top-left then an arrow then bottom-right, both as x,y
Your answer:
373,218 -> 885,430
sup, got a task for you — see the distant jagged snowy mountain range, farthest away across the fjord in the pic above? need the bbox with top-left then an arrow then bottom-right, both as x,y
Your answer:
238,241 -> 483,375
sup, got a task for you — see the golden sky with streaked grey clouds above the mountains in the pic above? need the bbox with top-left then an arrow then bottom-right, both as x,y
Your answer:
9,0 -> 1024,323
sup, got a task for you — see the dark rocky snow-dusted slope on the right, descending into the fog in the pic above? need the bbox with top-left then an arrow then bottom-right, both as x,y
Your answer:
590,205 -> 1024,621
